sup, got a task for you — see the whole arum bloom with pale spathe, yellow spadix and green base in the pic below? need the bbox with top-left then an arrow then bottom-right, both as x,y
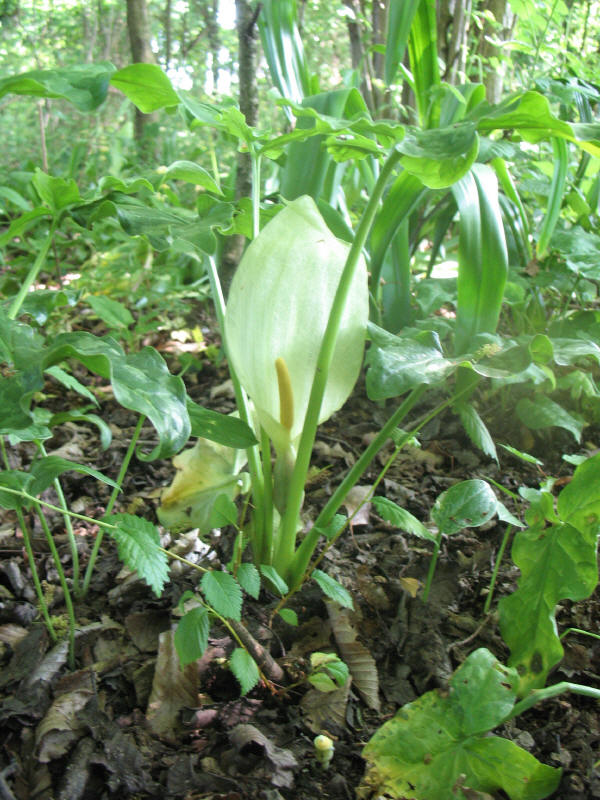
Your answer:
225,197 -> 369,582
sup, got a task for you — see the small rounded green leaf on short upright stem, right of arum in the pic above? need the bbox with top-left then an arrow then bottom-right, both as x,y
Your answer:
431,479 -> 498,536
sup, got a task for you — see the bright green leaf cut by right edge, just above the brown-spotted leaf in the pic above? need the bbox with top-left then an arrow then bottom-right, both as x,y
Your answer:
558,454 -> 600,534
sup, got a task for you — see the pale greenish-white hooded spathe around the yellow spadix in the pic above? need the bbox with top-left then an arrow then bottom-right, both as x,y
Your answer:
225,197 -> 369,453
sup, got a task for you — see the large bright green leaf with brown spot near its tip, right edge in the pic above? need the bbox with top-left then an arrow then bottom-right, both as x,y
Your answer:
498,522 -> 598,696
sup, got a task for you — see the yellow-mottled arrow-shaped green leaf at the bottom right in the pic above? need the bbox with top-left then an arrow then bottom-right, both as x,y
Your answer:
363,648 -> 561,800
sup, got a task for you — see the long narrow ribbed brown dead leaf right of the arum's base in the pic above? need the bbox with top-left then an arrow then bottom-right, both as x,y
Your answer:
325,602 -> 380,711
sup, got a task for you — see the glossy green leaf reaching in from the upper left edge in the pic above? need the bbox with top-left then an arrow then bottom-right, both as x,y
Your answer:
0,61 -> 115,111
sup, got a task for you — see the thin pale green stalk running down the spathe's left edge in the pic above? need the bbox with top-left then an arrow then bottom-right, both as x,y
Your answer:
207,255 -> 264,554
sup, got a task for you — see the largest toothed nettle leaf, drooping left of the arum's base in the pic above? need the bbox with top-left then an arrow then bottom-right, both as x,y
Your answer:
103,514 -> 169,597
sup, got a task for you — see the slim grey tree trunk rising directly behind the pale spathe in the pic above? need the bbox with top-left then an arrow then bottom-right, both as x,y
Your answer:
221,0 -> 260,291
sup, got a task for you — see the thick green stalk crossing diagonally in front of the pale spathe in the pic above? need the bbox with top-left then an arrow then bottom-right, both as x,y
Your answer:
274,149 -> 401,579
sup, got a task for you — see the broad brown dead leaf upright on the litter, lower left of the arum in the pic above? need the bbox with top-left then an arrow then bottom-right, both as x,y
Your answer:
146,630 -> 198,738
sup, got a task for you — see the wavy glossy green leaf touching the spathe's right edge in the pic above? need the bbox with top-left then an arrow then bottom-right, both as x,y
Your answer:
365,323 -> 455,401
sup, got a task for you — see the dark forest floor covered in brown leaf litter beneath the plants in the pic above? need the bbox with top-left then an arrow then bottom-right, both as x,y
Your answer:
0,314 -> 600,800
